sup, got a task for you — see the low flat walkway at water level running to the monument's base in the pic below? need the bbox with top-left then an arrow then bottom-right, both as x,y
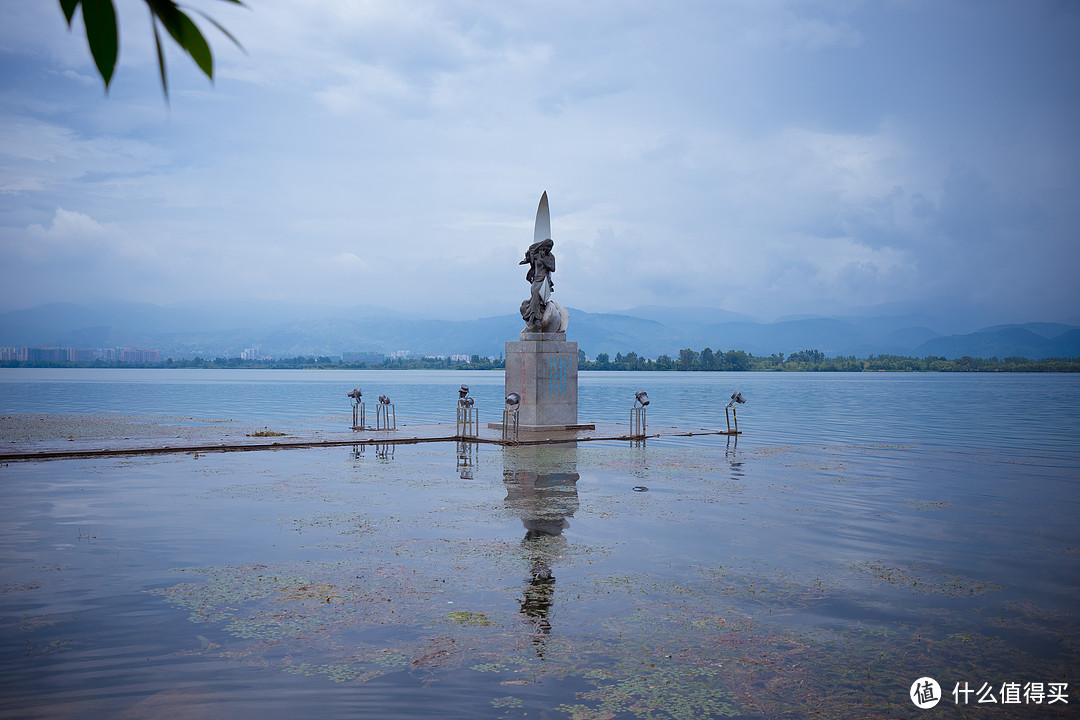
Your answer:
0,419 -> 741,462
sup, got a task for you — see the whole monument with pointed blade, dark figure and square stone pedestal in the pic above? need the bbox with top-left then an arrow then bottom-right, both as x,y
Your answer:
507,192 -> 593,432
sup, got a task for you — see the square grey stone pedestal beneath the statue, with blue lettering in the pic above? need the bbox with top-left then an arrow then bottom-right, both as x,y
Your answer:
507,332 -> 584,431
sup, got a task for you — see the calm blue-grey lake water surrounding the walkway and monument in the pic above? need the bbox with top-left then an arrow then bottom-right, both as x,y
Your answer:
0,369 -> 1080,720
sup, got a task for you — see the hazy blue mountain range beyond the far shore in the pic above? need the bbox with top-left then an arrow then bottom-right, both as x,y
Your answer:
0,301 -> 1080,359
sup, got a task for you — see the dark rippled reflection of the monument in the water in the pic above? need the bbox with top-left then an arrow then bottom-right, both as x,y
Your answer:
502,445 -> 580,656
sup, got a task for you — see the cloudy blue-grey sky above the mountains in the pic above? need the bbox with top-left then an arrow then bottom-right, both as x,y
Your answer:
0,0 -> 1080,322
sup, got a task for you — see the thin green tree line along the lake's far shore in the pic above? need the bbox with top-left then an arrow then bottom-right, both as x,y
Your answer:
0,348 -> 1080,372
